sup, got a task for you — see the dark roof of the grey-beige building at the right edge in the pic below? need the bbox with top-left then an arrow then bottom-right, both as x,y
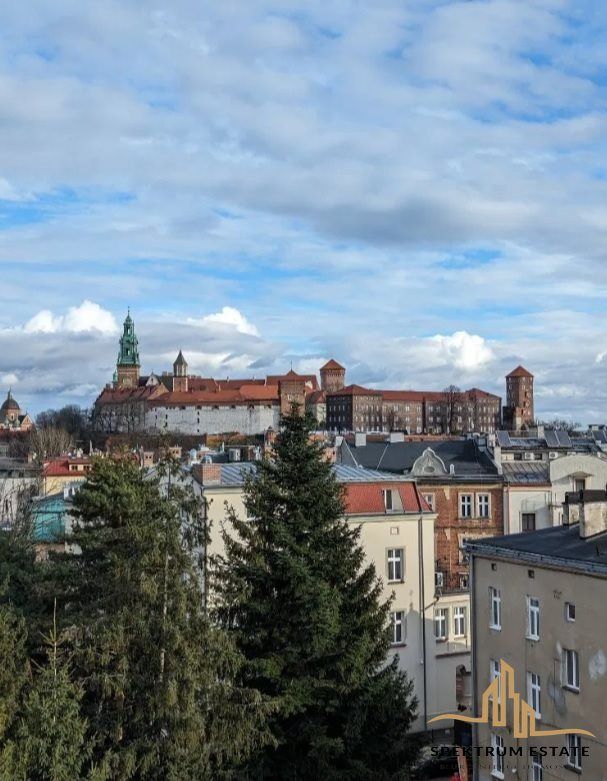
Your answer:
466,523 -> 607,574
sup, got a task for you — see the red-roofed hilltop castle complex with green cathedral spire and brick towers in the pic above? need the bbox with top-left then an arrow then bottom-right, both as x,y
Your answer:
95,312 -> 533,435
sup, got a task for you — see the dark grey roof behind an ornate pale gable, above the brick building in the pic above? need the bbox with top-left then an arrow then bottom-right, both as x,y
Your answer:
339,439 -> 497,480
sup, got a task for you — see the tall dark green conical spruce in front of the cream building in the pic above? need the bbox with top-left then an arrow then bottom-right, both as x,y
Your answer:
216,406 -> 417,781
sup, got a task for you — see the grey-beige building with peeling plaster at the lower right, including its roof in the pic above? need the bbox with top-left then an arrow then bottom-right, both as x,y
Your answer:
462,490 -> 607,781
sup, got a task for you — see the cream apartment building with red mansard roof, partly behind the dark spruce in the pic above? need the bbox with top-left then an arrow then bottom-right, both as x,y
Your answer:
192,463 -> 470,734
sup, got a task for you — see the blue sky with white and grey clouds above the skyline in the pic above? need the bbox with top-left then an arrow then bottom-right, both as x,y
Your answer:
0,0 -> 607,423
